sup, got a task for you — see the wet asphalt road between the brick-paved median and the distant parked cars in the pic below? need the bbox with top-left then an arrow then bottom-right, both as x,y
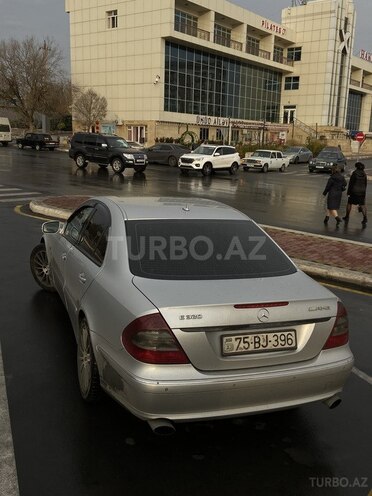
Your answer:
0,143 -> 372,243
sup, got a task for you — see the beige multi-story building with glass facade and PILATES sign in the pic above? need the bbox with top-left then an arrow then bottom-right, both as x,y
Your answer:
65,0 -> 372,144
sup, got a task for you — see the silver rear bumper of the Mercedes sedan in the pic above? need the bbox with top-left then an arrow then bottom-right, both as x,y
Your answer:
97,346 -> 353,422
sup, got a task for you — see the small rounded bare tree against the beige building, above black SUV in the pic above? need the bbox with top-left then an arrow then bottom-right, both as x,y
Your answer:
72,88 -> 107,131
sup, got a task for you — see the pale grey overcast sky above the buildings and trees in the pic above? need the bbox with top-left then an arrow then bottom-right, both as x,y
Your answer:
0,0 -> 372,72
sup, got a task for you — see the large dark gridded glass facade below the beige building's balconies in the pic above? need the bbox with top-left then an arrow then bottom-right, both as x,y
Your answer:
164,42 -> 282,122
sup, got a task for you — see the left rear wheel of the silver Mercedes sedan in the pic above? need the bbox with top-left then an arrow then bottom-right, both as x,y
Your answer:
76,317 -> 102,403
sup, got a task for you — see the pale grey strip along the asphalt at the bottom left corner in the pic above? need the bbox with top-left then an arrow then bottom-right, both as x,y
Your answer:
0,344 -> 19,496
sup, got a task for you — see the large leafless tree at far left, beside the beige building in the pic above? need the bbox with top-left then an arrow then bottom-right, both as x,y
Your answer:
0,37 -> 65,129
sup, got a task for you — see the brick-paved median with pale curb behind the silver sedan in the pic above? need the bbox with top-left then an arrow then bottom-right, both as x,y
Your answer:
30,196 -> 372,291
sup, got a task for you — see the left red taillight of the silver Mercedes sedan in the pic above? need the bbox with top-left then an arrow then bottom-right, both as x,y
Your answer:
121,313 -> 189,364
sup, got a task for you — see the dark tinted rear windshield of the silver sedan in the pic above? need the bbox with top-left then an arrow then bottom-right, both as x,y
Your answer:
126,219 -> 297,280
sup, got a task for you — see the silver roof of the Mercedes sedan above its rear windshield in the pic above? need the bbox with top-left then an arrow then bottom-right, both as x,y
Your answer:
97,196 -> 249,220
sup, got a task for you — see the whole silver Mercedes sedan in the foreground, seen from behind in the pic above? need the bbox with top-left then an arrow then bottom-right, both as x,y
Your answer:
30,197 -> 353,432
